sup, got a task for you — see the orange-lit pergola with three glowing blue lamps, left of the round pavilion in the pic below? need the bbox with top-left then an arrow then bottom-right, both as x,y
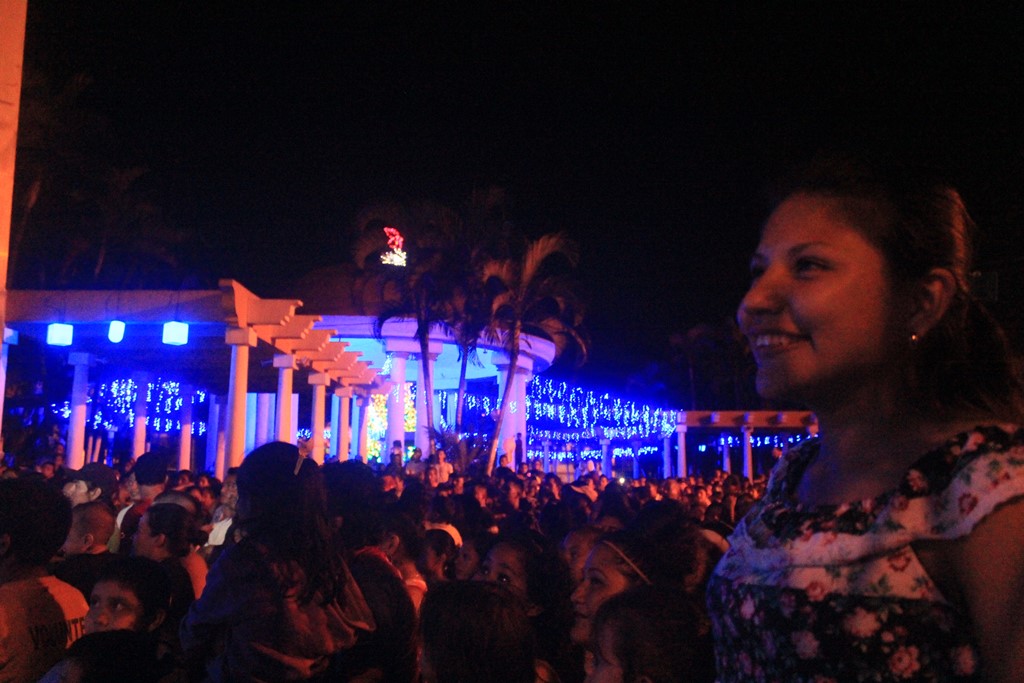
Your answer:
2,280 -> 380,475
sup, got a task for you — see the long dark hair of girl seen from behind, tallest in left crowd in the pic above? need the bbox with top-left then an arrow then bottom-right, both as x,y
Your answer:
238,441 -> 348,604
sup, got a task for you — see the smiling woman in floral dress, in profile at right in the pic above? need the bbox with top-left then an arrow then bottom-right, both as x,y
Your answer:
709,157 -> 1024,681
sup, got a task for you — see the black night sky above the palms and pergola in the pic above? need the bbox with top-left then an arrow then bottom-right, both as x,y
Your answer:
18,0 -> 1024,389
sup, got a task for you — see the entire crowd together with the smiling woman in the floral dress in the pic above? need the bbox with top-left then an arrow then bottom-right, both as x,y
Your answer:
6,160 -> 1024,683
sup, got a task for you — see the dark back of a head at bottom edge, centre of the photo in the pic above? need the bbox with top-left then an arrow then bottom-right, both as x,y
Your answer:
420,582 -> 537,683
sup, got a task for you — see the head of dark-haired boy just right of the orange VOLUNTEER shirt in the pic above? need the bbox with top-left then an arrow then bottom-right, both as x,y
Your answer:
85,557 -> 171,633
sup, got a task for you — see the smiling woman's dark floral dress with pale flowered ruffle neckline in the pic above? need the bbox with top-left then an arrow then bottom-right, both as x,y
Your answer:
708,426 -> 1024,683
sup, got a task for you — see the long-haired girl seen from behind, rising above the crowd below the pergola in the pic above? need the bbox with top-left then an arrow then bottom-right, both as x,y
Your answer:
181,442 -> 374,681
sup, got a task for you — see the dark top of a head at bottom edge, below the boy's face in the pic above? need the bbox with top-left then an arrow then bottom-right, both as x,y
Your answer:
60,631 -> 169,683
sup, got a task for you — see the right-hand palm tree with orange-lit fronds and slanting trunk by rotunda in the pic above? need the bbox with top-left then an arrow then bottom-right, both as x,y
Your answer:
482,233 -> 588,475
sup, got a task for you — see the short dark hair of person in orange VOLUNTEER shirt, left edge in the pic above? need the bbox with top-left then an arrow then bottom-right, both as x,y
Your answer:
0,478 -> 71,566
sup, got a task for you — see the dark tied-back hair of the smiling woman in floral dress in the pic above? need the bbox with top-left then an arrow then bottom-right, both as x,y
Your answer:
778,156 -> 1024,421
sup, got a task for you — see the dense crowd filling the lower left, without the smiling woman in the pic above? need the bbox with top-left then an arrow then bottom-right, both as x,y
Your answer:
0,442 -> 745,681
